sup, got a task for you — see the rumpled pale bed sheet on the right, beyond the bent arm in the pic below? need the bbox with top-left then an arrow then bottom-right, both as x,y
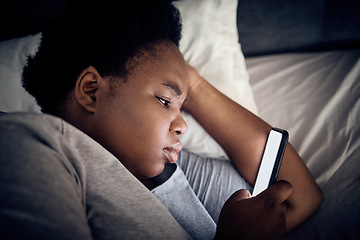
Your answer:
246,50 -> 360,240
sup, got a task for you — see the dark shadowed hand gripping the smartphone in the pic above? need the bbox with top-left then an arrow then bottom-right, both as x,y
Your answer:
215,181 -> 293,239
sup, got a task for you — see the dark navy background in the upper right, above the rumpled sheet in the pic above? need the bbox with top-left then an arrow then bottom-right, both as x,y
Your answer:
237,0 -> 360,56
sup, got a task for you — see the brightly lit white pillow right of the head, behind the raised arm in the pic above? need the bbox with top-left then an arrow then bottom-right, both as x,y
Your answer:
175,0 -> 258,158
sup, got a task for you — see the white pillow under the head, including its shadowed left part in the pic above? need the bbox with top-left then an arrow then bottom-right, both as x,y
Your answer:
0,0 -> 258,158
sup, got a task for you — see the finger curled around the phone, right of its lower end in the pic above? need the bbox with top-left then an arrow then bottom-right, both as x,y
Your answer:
258,180 -> 293,204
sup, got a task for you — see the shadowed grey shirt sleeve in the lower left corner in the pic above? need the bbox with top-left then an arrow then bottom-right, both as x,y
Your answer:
0,119 -> 91,239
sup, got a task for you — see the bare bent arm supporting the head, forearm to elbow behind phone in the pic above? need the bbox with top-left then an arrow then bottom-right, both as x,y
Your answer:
183,67 -> 322,230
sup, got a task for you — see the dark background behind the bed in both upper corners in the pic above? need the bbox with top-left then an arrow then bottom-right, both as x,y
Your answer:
0,0 -> 360,56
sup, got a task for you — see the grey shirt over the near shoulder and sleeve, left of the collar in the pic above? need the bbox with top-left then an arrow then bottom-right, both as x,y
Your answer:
0,113 -> 189,240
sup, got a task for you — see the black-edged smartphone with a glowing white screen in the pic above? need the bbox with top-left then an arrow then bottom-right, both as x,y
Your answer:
252,128 -> 289,197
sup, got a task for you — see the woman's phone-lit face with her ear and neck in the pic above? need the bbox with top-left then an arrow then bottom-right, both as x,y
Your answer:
64,44 -> 188,179
